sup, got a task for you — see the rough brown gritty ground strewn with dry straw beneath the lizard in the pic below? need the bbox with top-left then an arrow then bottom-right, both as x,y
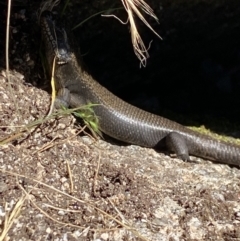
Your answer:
0,1 -> 240,241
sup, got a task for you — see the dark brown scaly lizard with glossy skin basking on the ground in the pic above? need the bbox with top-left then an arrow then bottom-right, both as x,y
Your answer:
40,11 -> 240,166
